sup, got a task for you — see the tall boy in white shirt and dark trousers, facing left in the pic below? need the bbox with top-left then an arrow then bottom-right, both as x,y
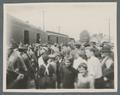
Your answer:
85,47 -> 103,89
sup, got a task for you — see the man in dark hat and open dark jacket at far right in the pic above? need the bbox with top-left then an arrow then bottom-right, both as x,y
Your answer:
101,44 -> 114,88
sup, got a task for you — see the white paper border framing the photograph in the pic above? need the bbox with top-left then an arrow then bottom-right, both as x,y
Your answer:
3,2 -> 118,93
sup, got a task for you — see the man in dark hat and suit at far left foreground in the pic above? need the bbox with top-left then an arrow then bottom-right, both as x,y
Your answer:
7,43 -> 28,89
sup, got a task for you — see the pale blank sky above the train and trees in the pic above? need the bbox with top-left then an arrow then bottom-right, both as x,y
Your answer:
4,2 -> 116,40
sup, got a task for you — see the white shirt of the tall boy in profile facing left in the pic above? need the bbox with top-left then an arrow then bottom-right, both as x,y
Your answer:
87,56 -> 102,79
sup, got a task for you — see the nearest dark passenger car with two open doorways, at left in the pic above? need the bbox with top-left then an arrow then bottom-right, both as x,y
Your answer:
6,15 -> 47,44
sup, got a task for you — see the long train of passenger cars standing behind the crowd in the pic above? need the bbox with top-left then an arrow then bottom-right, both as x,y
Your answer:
5,15 -> 70,44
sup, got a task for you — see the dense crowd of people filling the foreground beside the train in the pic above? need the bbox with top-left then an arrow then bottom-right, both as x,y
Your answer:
6,39 -> 114,89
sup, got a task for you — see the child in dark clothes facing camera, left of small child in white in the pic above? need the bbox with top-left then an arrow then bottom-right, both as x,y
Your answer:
60,57 -> 77,89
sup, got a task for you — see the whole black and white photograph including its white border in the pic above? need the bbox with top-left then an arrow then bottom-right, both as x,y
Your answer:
3,2 -> 118,93
